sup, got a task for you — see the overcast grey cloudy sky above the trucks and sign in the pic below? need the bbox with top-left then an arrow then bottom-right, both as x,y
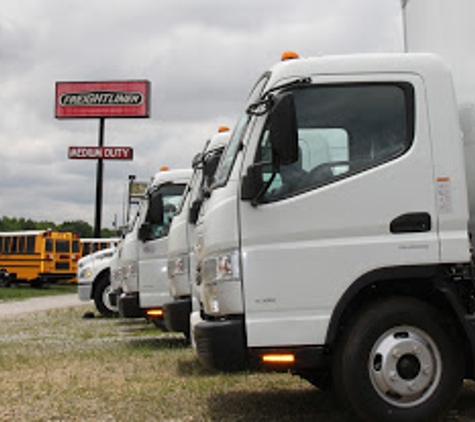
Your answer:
0,0 -> 403,231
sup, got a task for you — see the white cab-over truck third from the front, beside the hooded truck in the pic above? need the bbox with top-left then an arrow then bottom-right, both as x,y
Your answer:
117,169 -> 192,327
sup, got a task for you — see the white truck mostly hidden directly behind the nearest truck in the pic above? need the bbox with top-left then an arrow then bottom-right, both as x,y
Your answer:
164,126 -> 229,338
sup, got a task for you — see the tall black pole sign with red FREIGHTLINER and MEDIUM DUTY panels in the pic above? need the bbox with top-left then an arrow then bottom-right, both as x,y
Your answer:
55,81 -> 150,238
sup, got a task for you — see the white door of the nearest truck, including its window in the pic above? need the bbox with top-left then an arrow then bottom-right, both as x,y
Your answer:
239,75 -> 439,347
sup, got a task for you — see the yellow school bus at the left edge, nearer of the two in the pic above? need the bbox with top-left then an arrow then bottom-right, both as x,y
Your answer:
0,230 -> 81,286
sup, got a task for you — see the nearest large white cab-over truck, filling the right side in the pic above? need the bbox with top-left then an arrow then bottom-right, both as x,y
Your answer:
191,4 -> 475,421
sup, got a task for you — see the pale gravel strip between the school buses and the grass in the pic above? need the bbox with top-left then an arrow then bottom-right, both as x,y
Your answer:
0,294 -> 87,318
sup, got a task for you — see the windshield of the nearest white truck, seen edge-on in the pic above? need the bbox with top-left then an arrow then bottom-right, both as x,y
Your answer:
213,72 -> 270,188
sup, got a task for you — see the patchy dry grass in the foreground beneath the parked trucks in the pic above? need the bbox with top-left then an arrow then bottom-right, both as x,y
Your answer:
0,305 -> 475,422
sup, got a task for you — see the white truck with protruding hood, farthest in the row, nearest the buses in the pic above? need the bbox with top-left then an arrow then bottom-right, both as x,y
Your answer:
77,239 -> 118,316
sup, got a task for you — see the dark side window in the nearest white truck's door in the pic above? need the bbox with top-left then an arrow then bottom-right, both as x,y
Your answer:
256,83 -> 414,201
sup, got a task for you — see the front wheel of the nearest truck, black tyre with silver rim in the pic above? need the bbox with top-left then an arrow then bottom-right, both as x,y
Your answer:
332,297 -> 464,422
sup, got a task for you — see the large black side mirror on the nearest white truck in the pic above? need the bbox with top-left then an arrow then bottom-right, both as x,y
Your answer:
268,92 -> 299,165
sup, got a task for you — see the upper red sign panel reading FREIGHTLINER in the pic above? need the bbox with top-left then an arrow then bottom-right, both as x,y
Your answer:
56,81 -> 150,119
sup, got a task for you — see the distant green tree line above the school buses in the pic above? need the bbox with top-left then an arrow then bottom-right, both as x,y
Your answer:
0,216 -> 118,238
